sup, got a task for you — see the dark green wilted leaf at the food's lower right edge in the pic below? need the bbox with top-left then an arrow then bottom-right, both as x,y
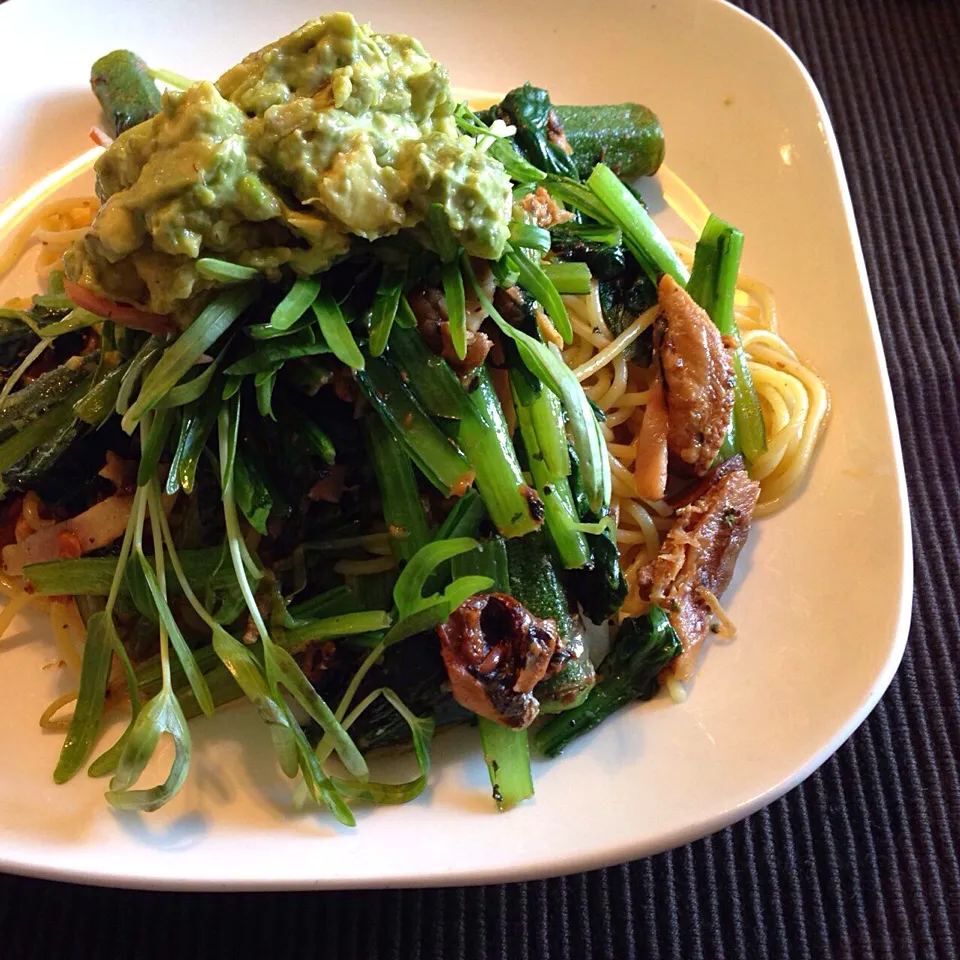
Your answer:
536,606 -> 681,757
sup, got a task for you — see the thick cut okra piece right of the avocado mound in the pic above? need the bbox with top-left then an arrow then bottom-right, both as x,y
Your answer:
554,103 -> 664,180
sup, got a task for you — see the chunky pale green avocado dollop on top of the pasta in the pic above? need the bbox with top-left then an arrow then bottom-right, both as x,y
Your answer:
66,13 -> 511,320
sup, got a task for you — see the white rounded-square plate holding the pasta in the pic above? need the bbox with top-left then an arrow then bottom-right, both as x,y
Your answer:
0,0 -> 912,889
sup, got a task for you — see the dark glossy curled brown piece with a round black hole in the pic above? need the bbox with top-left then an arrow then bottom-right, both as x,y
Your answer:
437,593 -> 559,729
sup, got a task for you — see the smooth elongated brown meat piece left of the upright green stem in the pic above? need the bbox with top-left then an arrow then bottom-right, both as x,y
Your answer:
653,275 -> 734,476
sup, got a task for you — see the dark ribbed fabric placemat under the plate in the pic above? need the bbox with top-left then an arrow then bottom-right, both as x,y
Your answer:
0,0 -> 960,960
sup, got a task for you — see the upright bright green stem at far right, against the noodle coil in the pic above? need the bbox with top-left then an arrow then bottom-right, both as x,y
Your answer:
687,214 -> 767,463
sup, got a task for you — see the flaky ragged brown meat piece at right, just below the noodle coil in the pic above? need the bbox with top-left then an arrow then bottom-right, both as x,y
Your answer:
638,470 -> 760,680
